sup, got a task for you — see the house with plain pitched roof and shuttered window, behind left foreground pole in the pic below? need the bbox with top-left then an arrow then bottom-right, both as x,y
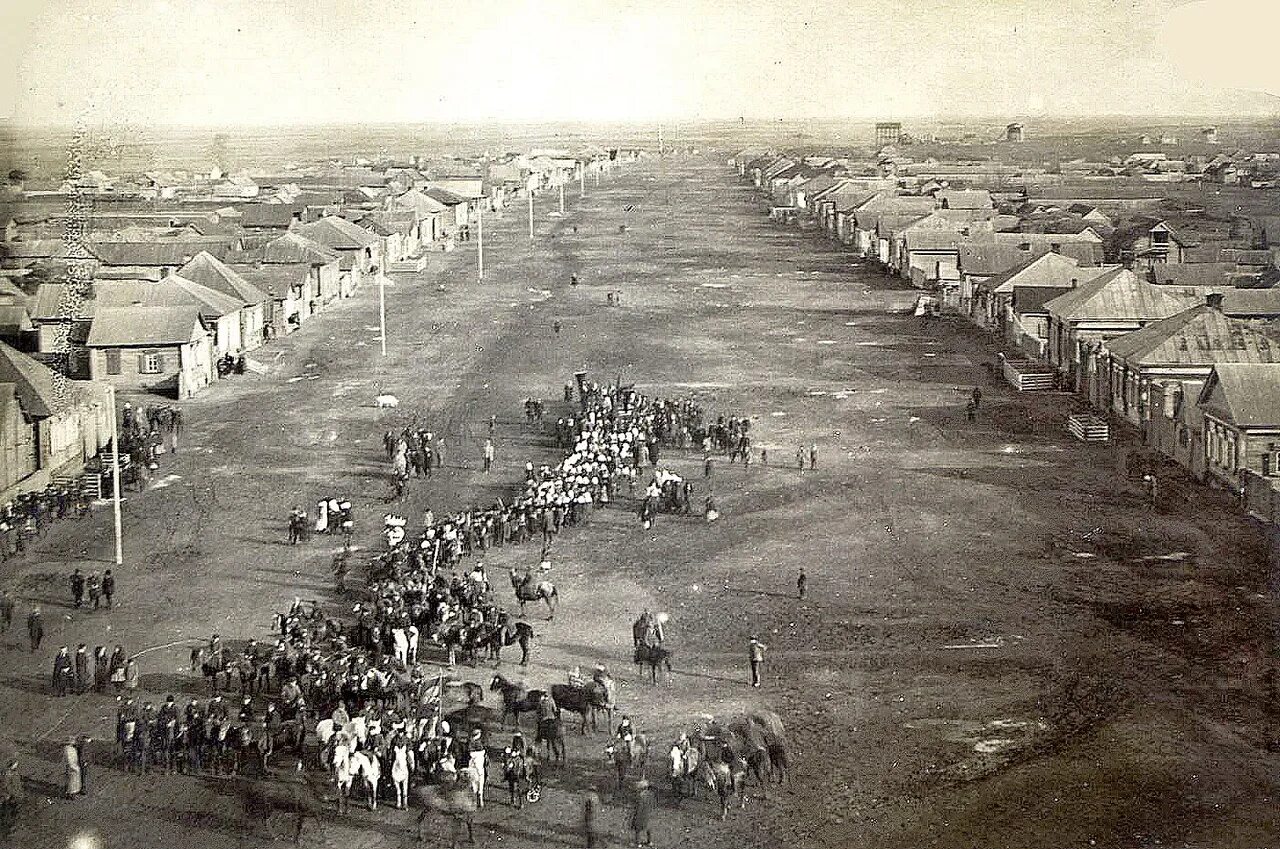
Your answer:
86,303 -> 215,398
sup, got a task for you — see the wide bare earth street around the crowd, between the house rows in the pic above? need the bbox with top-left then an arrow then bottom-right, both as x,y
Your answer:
0,159 -> 1280,849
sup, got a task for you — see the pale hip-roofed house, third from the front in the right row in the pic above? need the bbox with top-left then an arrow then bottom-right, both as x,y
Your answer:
1044,268 -> 1203,394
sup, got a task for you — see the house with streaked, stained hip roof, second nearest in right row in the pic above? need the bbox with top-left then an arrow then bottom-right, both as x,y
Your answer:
1098,293 -> 1280,428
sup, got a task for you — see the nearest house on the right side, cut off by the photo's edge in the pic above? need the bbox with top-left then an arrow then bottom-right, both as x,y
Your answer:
1197,362 -> 1280,490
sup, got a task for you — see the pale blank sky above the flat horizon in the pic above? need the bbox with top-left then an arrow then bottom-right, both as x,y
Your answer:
0,0 -> 1280,125
